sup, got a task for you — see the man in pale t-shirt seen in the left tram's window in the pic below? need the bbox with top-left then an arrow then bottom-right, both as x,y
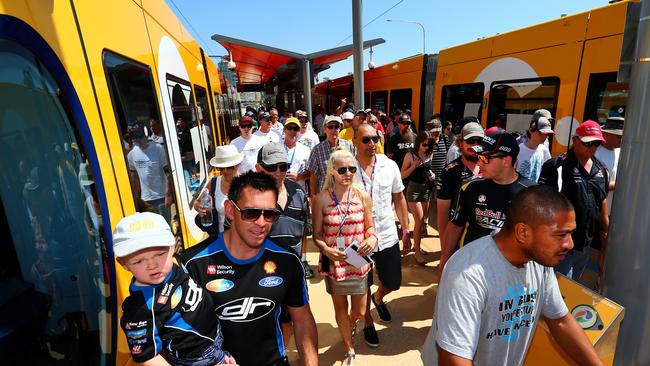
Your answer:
126,122 -> 172,222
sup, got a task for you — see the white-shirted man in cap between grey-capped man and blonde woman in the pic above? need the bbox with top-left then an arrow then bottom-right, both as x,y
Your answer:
283,117 -> 311,192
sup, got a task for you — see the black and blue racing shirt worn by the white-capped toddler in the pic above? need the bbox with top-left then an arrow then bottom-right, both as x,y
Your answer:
120,264 -> 221,362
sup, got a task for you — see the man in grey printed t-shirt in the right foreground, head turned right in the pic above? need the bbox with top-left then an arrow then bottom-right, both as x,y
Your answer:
422,186 -> 601,365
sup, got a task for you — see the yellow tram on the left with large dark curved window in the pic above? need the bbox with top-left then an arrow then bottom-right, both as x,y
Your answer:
0,0 -> 237,365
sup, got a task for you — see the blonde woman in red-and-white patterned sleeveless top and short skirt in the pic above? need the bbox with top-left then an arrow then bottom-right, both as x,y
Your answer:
313,149 -> 377,365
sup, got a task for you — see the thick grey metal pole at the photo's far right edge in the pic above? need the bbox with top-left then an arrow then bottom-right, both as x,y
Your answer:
603,0 -> 650,365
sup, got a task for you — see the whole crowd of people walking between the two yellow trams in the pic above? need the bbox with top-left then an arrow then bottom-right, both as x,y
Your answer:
114,100 -> 623,365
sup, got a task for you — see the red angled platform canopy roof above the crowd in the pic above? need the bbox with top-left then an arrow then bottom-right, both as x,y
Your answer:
212,34 -> 385,84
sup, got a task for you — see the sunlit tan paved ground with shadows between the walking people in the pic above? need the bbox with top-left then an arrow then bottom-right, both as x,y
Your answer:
288,220 -> 440,366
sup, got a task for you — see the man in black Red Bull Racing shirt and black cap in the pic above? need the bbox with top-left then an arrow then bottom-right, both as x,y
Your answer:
440,130 -> 535,275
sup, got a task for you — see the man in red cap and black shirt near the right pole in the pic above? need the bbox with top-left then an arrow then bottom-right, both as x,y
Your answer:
539,120 -> 609,280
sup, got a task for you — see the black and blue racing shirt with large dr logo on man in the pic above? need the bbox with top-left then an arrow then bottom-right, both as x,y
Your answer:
180,236 -> 309,366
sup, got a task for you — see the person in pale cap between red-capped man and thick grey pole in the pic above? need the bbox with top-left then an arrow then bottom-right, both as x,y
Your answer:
595,117 -> 625,214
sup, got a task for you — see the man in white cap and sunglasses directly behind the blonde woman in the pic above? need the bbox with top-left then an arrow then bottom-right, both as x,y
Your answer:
307,116 -> 354,197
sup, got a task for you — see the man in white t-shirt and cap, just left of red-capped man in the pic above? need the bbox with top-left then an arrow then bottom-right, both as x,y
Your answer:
515,117 -> 555,182
